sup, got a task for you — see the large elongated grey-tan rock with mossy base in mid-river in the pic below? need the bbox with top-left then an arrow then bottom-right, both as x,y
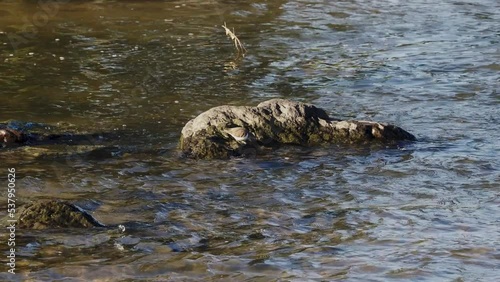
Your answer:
180,99 -> 416,158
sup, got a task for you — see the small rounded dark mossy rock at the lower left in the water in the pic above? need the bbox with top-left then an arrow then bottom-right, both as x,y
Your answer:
18,200 -> 104,229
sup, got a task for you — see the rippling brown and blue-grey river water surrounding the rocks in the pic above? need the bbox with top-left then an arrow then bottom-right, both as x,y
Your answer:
0,0 -> 500,281
